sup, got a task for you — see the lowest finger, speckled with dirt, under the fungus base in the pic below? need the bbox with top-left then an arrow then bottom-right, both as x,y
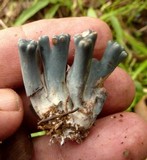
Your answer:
33,112 -> 147,160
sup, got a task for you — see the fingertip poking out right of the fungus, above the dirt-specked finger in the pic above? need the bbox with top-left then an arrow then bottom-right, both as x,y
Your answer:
101,67 -> 135,116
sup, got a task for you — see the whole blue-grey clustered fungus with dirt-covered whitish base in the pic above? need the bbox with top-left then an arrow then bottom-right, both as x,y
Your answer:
18,30 -> 127,145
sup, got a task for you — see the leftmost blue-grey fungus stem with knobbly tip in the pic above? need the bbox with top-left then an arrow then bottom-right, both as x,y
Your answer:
18,39 -> 42,96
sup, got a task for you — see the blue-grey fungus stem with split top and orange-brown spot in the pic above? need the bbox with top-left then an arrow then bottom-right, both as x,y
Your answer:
39,35 -> 70,97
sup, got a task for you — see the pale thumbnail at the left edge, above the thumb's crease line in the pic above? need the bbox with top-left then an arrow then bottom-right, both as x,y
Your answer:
0,89 -> 20,111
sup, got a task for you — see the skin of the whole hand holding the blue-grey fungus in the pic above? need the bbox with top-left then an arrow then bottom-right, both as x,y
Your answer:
0,17 -> 147,160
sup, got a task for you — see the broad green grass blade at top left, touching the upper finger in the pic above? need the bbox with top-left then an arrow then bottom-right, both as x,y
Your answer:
14,0 -> 50,26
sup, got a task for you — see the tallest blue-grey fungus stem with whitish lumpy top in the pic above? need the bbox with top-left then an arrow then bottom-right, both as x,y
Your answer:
67,30 -> 97,106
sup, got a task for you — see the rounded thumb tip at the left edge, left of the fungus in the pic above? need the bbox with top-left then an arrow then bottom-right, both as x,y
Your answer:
0,89 -> 23,141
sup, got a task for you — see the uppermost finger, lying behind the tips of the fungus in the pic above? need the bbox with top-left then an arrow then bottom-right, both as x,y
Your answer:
0,17 -> 111,88
